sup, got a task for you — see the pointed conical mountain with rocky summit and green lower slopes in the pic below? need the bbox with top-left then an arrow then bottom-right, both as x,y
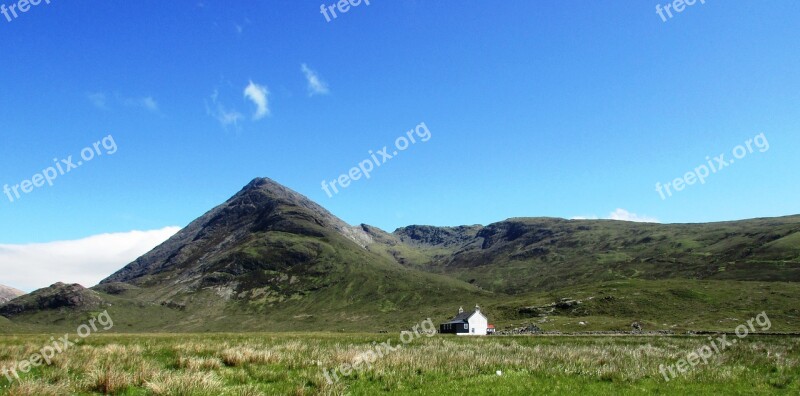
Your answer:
95,179 -> 488,329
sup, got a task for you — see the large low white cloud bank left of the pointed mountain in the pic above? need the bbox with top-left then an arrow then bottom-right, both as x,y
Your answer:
0,227 -> 180,292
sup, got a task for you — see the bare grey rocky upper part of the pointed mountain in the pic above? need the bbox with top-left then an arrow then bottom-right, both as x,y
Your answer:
102,178 -> 372,283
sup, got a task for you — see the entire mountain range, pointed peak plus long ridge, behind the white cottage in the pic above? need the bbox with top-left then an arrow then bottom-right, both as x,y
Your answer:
0,178 -> 800,332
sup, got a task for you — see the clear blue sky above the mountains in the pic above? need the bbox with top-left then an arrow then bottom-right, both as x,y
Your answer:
0,0 -> 800,260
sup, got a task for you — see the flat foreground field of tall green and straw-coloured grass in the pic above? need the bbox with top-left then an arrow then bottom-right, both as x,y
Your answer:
0,333 -> 800,396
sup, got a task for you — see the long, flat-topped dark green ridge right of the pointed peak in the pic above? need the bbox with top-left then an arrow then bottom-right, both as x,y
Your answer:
372,216 -> 800,294
